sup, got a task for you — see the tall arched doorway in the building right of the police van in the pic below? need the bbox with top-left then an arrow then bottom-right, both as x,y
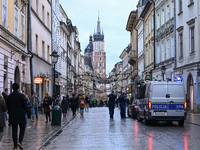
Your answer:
187,74 -> 194,110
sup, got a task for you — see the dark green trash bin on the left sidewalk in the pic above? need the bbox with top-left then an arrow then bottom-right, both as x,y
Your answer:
51,106 -> 61,125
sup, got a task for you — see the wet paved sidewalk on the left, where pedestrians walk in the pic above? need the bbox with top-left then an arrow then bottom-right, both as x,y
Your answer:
1,111 -> 72,150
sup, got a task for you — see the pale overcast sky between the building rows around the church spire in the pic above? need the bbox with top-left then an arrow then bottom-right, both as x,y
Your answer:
60,0 -> 138,73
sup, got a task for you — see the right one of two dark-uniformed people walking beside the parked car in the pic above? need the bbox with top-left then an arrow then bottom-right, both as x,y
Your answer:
117,93 -> 126,118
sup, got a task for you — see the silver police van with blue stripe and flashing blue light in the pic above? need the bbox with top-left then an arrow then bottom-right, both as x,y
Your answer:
137,81 -> 187,126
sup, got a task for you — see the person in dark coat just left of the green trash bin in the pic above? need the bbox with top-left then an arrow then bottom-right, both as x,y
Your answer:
43,93 -> 52,123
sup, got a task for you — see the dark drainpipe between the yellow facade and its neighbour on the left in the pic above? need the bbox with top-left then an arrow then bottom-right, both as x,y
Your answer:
27,0 -> 34,95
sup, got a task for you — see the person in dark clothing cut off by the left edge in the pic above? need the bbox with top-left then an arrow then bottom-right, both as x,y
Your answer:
0,95 -> 7,149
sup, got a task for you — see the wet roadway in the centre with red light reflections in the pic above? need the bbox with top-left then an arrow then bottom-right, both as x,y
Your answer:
43,107 -> 200,150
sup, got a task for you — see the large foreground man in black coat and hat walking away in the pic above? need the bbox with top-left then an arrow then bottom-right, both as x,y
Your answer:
7,83 -> 31,150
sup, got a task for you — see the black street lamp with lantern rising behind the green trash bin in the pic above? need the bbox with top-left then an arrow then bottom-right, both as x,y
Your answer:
50,51 -> 59,100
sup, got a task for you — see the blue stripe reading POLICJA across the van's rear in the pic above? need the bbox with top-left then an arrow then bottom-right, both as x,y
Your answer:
151,103 -> 184,110
